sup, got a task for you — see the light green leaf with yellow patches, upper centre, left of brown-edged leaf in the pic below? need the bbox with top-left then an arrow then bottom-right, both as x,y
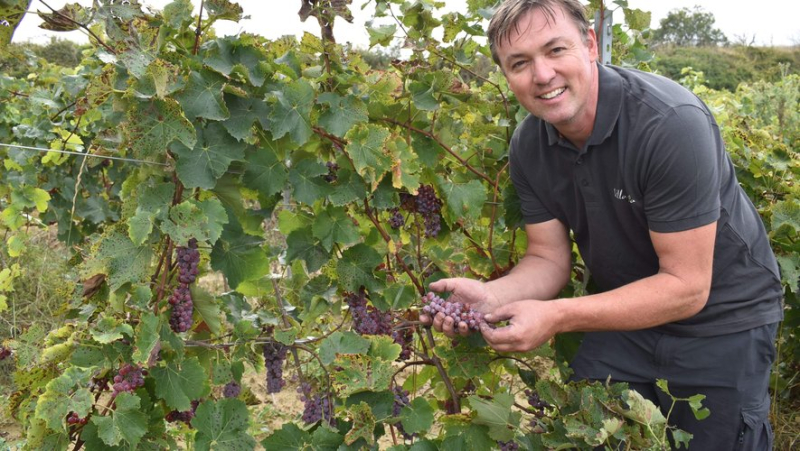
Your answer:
346,124 -> 392,185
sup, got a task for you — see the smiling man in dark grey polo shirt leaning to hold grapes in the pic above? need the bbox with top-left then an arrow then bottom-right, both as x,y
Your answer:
422,0 -> 782,451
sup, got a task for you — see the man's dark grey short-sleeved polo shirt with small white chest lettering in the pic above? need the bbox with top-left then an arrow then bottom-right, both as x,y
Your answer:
509,65 -> 783,336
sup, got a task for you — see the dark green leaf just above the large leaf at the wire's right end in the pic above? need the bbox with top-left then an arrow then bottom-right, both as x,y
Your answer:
175,70 -> 230,121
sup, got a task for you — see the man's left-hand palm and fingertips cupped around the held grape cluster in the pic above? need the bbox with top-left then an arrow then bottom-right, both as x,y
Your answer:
419,278 -> 500,338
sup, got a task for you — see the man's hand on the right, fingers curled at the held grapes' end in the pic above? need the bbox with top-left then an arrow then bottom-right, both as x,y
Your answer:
481,300 -> 560,352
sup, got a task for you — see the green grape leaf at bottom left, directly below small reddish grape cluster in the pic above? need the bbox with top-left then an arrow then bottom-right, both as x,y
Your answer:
91,392 -> 147,448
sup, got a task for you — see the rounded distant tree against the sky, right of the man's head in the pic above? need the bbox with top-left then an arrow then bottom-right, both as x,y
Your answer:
653,6 -> 728,47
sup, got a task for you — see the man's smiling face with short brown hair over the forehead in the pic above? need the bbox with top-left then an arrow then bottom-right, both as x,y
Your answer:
497,8 -> 597,133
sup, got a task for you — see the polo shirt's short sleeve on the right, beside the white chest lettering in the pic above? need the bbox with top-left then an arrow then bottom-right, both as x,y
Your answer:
640,105 -> 724,232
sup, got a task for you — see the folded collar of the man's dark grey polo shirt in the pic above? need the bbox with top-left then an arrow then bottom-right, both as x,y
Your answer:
545,63 -> 622,146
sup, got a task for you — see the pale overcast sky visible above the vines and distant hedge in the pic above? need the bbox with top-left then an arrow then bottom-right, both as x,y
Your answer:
14,0 -> 800,47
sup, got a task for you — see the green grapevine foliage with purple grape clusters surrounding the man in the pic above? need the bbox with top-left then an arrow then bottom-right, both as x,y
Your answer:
0,0 -> 800,450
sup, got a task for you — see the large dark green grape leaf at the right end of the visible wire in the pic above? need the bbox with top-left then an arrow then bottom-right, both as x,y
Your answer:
171,122 -> 245,189
